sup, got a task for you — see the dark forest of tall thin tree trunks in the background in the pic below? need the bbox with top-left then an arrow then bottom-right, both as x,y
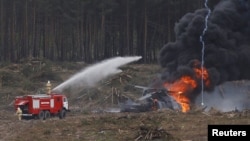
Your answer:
0,0 -> 219,63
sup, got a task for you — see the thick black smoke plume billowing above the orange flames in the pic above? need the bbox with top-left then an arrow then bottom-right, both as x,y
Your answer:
159,0 -> 250,101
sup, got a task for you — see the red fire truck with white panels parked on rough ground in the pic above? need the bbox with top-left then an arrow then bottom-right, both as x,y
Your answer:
14,93 -> 69,120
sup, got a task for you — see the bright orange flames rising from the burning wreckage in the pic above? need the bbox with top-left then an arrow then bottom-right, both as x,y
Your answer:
164,68 -> 210,113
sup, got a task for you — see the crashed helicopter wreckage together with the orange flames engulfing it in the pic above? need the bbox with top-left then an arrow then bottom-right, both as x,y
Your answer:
120,60 -> 210,113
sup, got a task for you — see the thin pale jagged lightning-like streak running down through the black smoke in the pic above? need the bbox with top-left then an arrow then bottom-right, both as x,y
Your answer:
200,0 -> 211,106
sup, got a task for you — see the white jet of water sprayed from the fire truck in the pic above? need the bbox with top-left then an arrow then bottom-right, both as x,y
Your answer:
52,56 -> 141,92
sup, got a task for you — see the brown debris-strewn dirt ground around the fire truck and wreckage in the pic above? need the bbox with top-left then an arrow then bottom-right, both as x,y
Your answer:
0,60 -> 250,141
